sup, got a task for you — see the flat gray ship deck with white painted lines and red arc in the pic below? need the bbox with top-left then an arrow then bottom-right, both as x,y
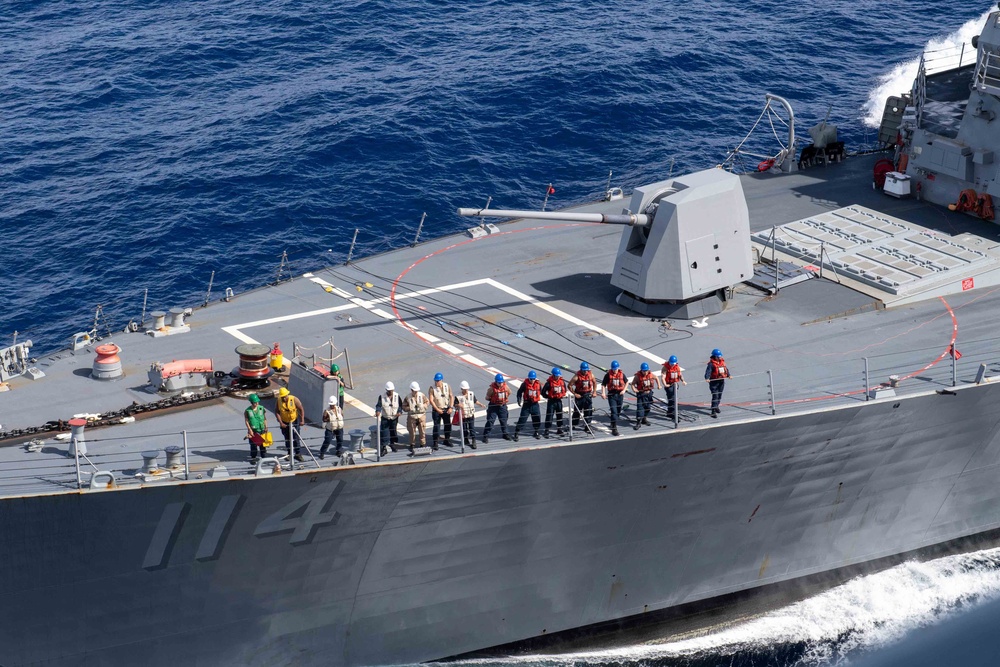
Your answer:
0,156 -> 1000,496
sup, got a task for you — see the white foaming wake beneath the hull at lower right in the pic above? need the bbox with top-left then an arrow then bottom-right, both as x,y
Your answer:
452,549 -> 1000,667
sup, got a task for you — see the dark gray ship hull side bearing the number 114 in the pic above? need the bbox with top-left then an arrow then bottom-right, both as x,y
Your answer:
0,384 -> 1000,667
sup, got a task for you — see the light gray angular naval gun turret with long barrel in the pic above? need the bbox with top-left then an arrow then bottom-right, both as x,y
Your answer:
458,169 -> 753,319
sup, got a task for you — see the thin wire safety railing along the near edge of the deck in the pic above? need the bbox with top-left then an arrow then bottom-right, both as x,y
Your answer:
0,339 -> 1000,496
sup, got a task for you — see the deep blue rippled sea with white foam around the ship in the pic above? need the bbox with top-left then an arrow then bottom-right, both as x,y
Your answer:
0,0 -> 994,666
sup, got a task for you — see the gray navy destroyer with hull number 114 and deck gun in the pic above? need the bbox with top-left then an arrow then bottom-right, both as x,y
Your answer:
0,13 -> 1000,667
